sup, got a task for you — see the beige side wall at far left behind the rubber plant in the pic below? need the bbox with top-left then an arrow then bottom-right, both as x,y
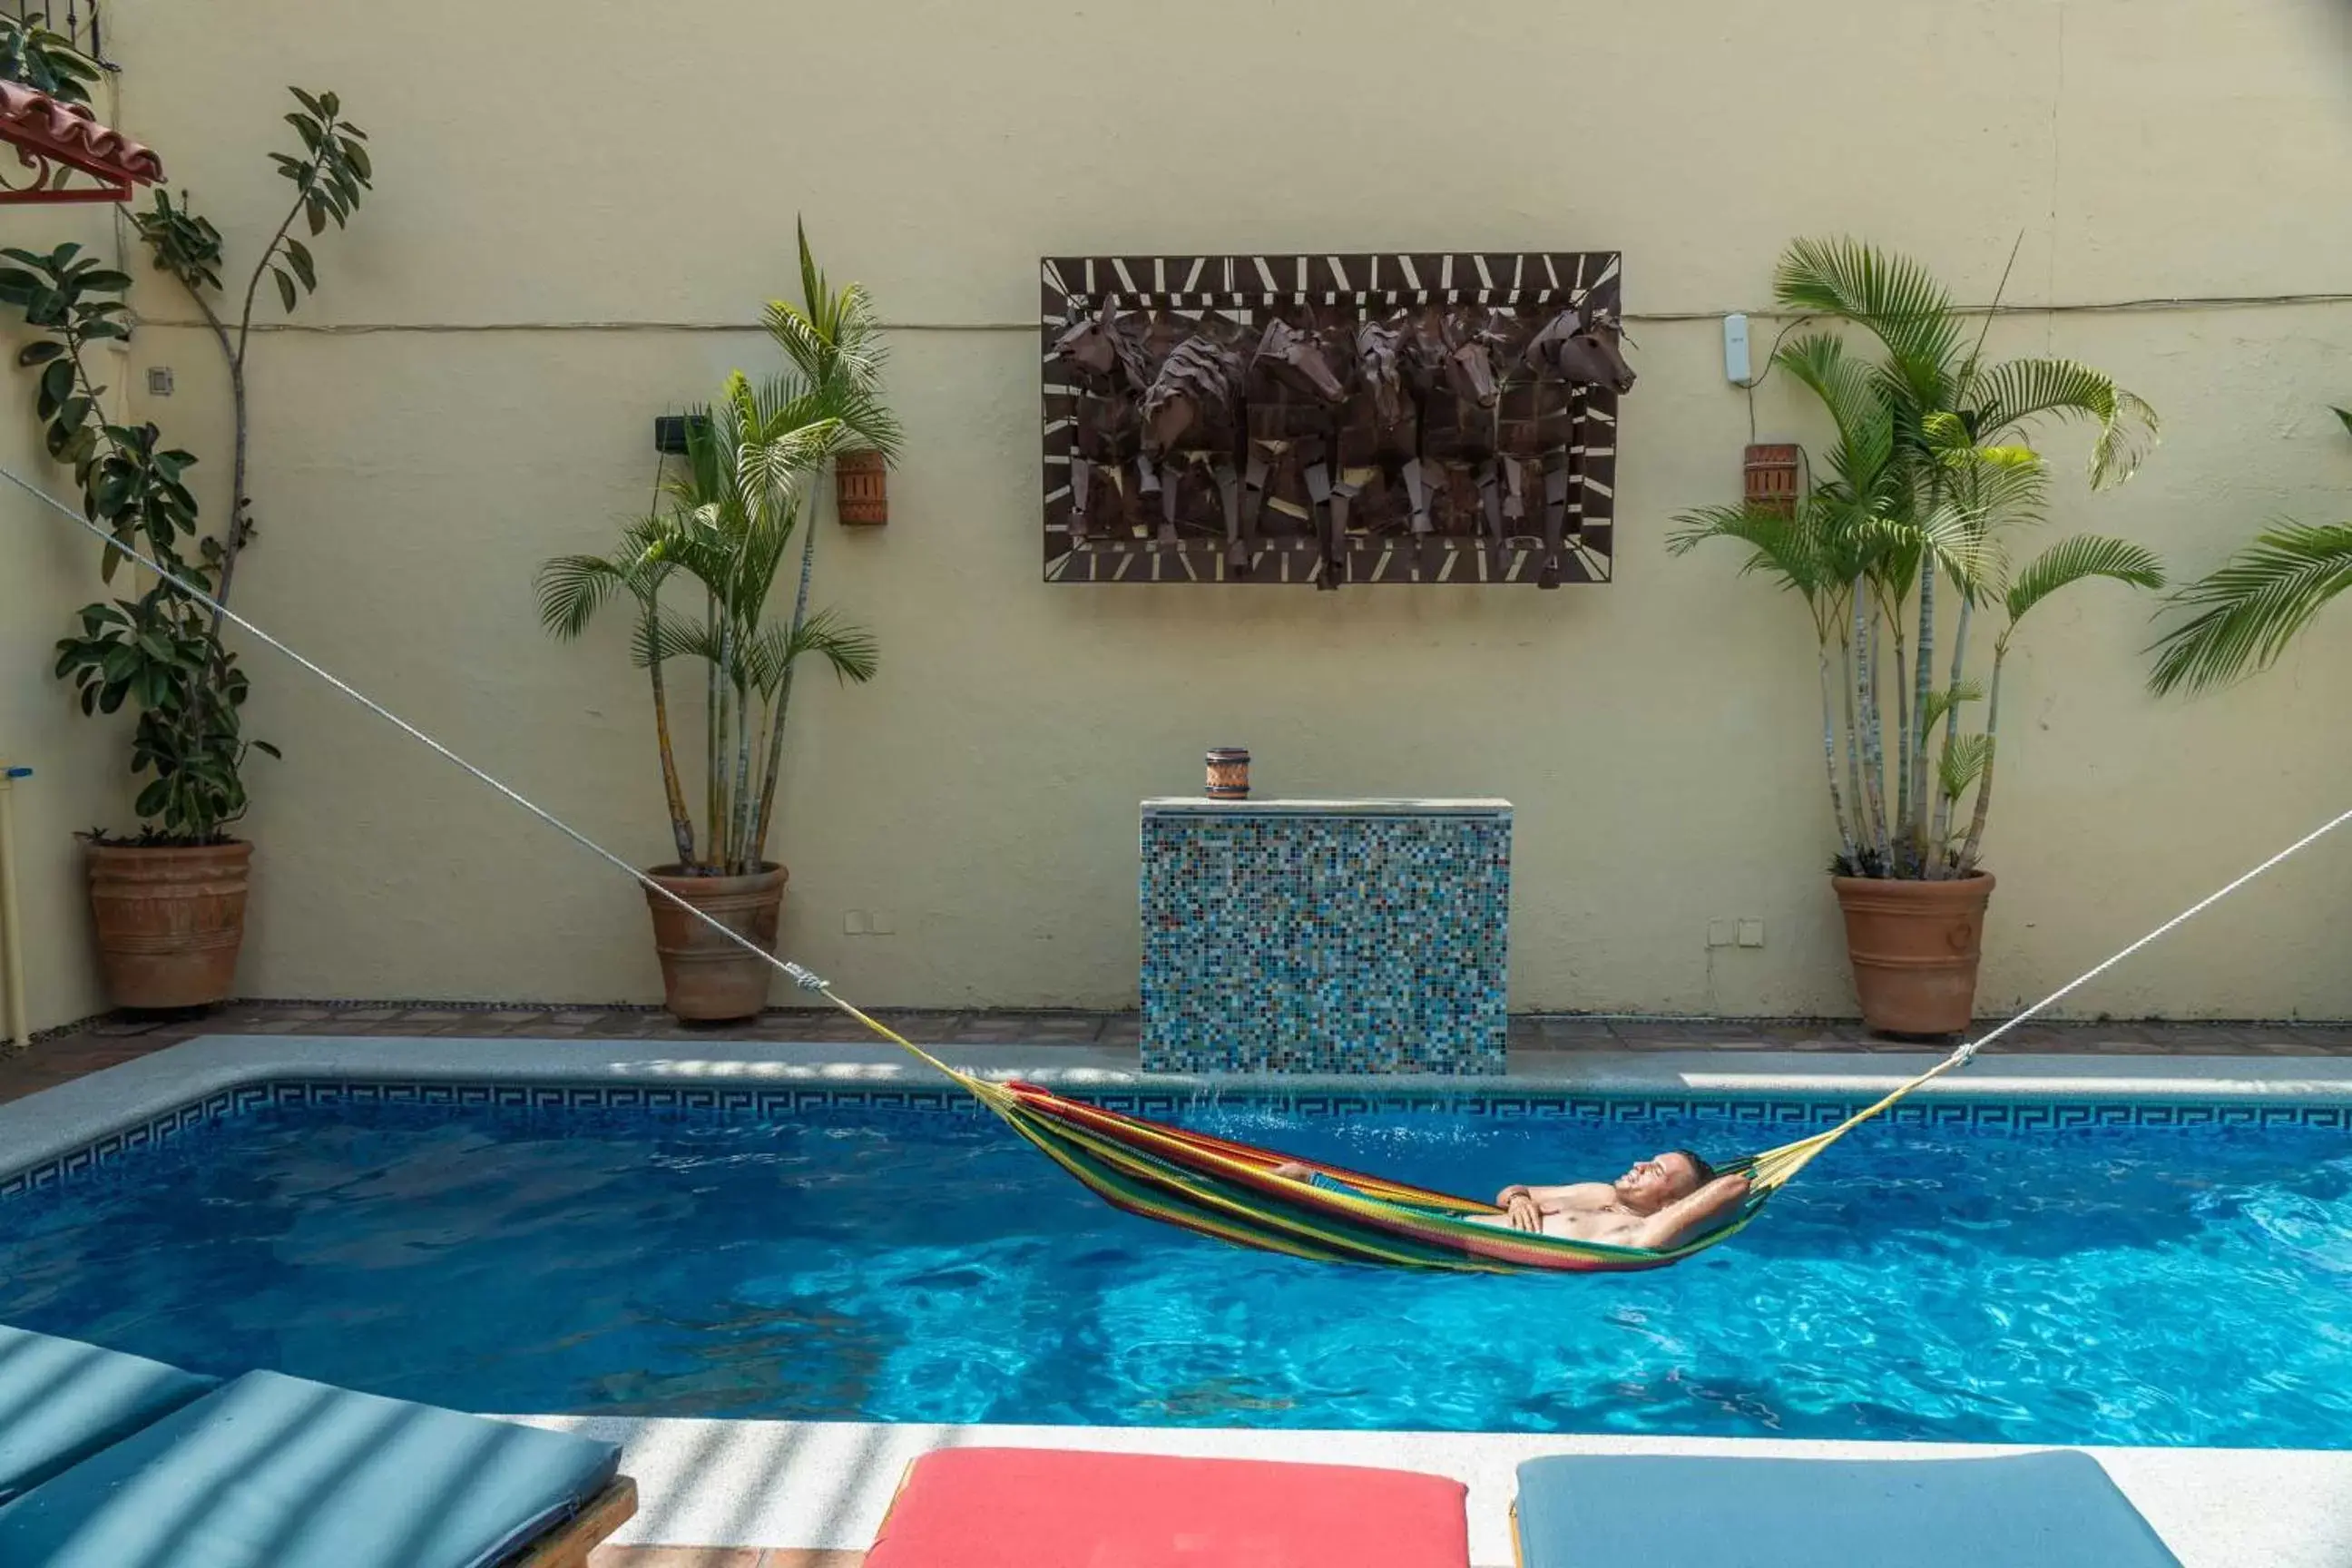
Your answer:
0,207 -> 130,1032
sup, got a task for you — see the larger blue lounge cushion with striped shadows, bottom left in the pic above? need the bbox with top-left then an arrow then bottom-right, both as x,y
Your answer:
0,1373 -> 621,1568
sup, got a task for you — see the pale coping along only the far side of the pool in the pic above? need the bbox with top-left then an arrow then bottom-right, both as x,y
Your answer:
14,1034 -> 2352,1185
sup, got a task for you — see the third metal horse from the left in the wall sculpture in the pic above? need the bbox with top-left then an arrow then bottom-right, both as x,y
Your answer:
1228,315 -> 1348,588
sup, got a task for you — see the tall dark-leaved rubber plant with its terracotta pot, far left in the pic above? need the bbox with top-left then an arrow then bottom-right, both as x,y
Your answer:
0,89 -> 369,1008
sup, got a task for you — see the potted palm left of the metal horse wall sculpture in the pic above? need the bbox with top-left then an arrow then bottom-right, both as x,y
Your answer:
539,235 -> 898,1023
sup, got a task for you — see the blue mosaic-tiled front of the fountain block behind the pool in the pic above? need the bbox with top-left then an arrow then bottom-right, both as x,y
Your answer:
1139,811 -> 1510,1074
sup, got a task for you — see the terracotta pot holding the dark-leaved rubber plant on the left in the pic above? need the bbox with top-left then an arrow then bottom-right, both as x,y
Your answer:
89,844 -> 254,1008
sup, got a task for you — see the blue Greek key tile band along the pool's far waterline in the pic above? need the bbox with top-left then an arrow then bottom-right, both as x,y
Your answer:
0,1082 -> 2352,1199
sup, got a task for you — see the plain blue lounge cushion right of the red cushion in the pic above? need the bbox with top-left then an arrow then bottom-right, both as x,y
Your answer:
1514,1450 -> 2180,1568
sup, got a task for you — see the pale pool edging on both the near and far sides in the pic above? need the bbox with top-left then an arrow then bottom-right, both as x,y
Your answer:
14,1034 -> 2352,1568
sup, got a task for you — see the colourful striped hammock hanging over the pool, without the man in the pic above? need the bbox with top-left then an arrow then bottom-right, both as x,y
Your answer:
811,1005 -> 1974,1274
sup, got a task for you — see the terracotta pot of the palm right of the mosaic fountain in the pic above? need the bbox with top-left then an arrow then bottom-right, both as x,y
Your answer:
1830,872 -> 1992,1034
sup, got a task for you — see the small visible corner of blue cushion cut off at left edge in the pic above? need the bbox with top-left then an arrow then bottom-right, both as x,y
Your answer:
0,1326 -> 221,1502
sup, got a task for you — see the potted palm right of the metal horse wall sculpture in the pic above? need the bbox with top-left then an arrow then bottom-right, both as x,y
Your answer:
1670,240 -> 2164,1034
